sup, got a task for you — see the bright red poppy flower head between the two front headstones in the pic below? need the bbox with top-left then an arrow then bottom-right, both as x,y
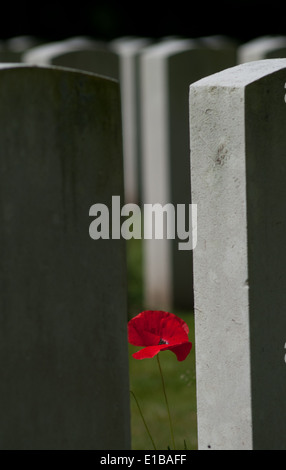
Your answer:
128,310 -> 192,361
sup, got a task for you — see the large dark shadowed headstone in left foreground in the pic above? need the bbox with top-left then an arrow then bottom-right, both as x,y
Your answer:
0,64 -> 129,450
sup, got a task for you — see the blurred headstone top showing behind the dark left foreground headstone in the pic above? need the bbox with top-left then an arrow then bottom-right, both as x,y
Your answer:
22,37 -> 119,79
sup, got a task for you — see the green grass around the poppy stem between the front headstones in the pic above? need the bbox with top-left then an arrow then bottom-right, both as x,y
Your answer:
127,239 -> 197,450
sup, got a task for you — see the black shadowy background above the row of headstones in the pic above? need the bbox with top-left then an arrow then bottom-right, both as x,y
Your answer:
0,0 -> 286,42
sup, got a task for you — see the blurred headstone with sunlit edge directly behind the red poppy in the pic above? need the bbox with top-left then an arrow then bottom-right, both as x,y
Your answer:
141,40 -> 235,309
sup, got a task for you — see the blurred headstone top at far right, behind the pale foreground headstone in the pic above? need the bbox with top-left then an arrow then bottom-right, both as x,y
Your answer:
237,36 -> 286,64
